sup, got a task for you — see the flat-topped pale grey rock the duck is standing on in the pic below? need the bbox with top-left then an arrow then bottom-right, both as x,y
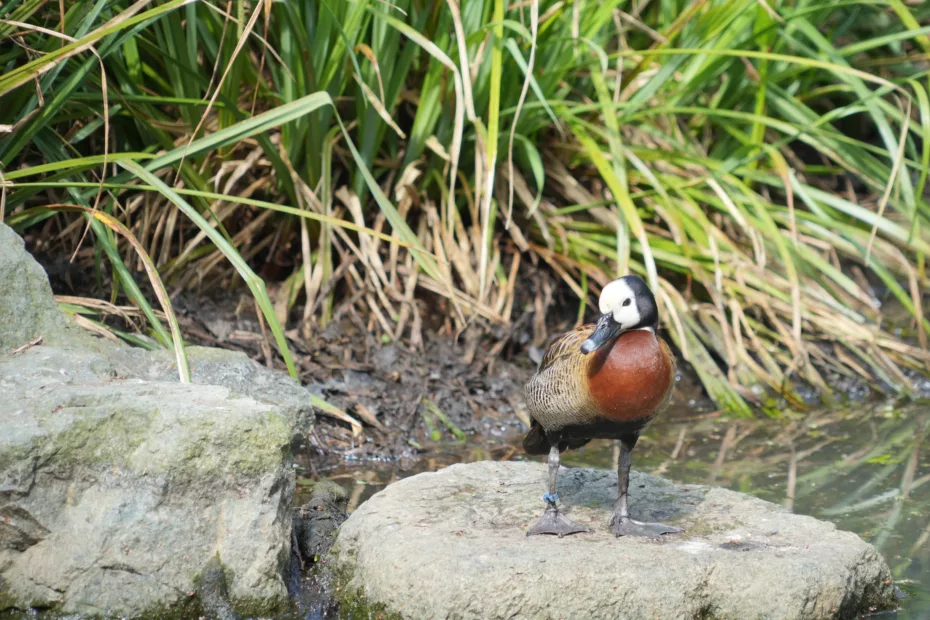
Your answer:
331,462 -> 894,620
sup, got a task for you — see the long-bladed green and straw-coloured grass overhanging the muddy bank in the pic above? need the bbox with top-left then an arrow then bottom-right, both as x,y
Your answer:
0,0 -> 930,414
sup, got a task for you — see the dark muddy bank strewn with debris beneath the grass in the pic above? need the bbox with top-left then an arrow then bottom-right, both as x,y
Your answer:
163,286 -> 714,470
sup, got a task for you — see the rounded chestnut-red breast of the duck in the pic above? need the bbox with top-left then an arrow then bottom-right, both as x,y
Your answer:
588,330 -> 675,421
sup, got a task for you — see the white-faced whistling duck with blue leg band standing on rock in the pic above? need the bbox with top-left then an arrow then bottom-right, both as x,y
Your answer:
523,275 -> 681,538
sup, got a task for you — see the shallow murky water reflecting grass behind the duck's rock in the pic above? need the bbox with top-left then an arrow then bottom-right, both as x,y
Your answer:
302,404 -> 930,620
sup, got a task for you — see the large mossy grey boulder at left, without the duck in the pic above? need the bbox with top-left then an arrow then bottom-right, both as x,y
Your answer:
0,224 -> 313,617
